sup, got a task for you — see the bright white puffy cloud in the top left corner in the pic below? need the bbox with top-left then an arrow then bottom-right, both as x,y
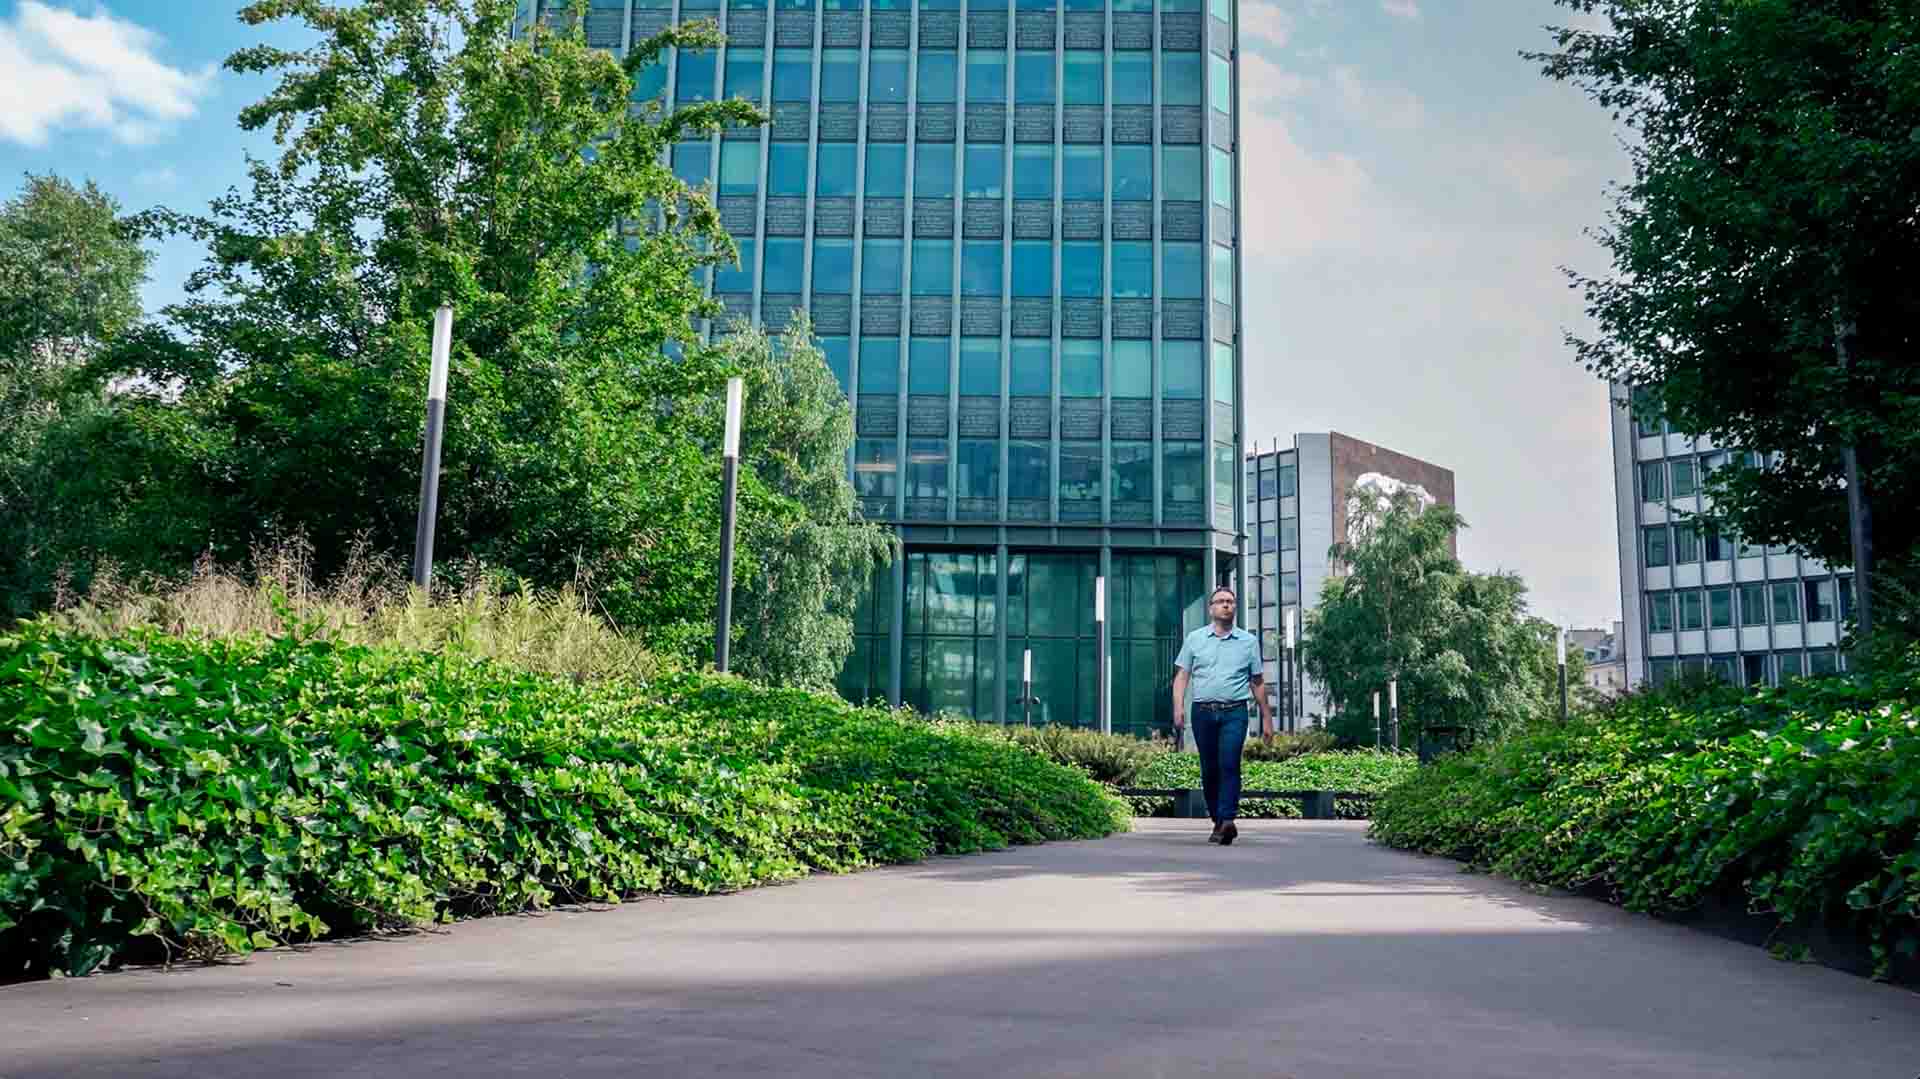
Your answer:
0,0 -> 215,146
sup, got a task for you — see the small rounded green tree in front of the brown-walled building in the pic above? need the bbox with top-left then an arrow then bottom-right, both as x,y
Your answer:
1300,486 -> 1559,747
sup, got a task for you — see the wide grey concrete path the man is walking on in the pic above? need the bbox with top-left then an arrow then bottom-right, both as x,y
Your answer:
11,822 -> 1920,1079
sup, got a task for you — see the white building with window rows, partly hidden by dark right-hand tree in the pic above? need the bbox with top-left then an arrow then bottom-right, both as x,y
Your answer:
1613,386 -> 1853,685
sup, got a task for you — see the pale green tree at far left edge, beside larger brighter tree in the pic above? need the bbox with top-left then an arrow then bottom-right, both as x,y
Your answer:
0,175 -> 150,616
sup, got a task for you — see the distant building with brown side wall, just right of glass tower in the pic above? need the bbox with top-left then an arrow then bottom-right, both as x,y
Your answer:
1242,432 -> 1457,730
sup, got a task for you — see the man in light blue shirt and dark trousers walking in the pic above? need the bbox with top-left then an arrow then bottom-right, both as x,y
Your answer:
1173,587 -> 1273,847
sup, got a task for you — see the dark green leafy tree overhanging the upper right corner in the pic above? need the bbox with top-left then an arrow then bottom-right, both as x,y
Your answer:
1524,0 -> 1920,633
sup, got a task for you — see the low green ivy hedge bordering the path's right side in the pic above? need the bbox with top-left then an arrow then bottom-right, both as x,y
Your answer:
1371,655 -> 1920,973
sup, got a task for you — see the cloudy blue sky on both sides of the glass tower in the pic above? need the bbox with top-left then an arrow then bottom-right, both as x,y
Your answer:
0,0 -> 1626,624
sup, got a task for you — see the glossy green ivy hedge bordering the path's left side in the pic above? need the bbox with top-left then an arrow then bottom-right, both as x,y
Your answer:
0,620 -> 1127,977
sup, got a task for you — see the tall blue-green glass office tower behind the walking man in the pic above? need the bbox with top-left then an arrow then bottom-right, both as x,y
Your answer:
541,0 -> 1242,731
